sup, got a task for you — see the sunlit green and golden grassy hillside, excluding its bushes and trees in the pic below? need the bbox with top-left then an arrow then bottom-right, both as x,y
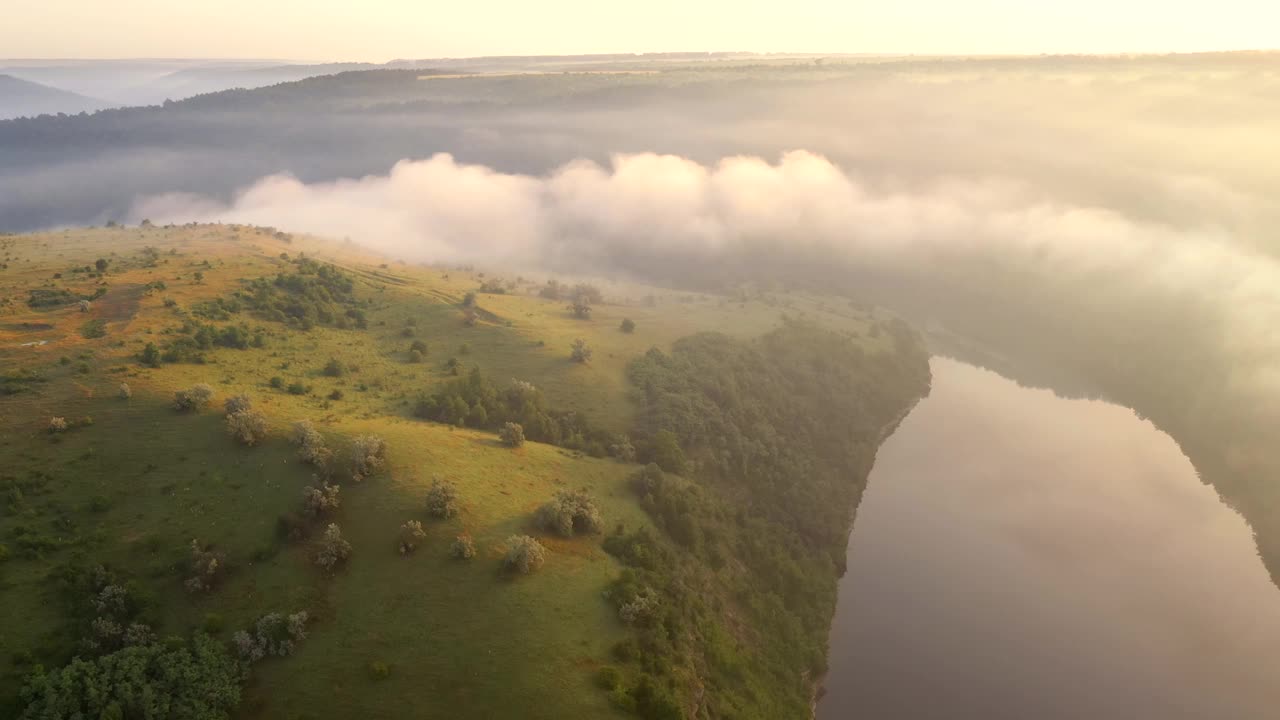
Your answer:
0,225 -> 909,717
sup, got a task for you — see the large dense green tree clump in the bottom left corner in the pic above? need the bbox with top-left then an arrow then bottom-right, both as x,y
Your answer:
19,633 -> 242,720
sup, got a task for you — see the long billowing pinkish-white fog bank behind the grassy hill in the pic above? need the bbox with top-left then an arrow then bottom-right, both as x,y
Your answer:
132,151 -> 1280,387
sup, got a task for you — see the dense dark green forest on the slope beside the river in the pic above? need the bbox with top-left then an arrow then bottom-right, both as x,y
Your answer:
605,323 -> 929,720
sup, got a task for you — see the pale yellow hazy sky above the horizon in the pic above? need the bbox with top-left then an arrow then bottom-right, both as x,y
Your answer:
0,0 -> 1280,61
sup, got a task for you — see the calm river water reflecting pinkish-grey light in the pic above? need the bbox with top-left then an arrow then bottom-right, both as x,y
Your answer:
818,357 -> 1280,720
